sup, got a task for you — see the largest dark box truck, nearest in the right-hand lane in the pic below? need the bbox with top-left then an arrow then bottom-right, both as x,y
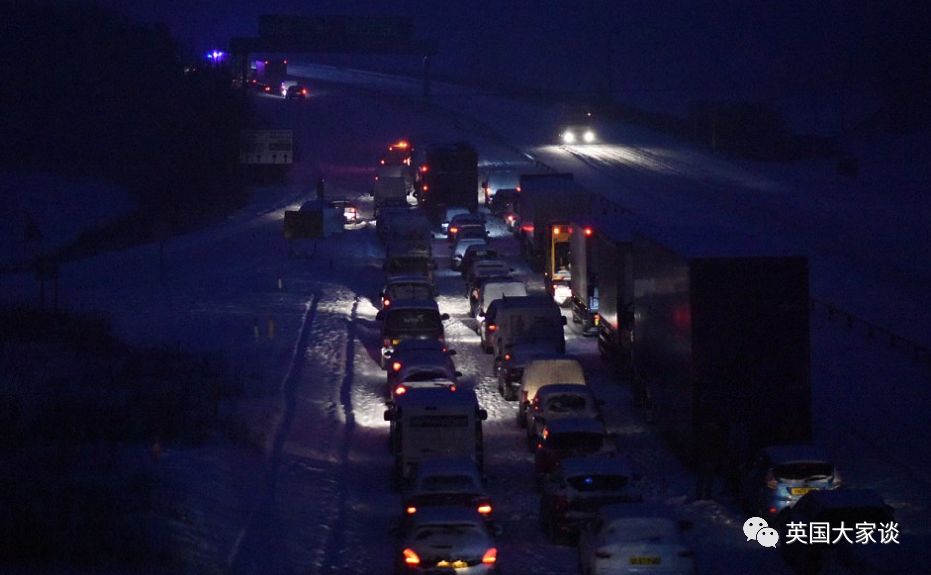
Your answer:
628,228 -> 811,473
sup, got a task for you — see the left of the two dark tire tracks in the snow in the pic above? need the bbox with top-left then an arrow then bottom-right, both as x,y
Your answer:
227,292 -> 320,573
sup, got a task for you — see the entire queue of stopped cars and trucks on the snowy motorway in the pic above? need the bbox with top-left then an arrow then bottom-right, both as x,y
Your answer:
314,136 -> 894,574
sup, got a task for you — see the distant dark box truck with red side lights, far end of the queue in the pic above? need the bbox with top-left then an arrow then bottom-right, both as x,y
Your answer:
416,142 -> 479,224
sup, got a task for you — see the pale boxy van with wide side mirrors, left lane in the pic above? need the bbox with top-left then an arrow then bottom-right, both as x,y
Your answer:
384,387 -> 488,486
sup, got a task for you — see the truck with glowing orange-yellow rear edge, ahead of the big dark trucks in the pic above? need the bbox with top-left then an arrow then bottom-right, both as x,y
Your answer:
515,173 -> 591,280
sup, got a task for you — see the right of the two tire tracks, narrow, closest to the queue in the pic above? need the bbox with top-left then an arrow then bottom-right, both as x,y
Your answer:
321,295 -> 360,574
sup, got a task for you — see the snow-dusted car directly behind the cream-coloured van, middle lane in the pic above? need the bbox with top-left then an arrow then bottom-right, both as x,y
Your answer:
525,388 -> 604,452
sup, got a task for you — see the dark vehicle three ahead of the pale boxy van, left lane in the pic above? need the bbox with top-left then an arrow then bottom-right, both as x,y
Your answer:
375,299 -> 449,369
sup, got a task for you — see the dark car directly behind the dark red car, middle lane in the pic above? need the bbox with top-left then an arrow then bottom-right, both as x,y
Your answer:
540,457 -> 643,540
